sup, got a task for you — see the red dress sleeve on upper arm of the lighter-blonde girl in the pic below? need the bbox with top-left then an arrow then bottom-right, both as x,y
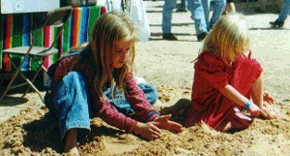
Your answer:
194,54 -> 229,89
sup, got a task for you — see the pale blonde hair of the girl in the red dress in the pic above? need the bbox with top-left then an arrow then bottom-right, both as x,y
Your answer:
201,13 -> 250,63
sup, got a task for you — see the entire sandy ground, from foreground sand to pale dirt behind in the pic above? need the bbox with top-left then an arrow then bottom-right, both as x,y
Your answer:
0,0 -> 290,156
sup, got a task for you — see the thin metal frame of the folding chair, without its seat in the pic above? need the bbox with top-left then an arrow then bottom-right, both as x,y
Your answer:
0,6 -> 73,102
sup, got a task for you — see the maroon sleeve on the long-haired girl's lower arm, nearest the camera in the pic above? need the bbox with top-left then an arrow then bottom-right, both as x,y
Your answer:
97,99 -> 137,133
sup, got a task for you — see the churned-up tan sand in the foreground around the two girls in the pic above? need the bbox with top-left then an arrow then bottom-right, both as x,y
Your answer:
0,86 -> 290,156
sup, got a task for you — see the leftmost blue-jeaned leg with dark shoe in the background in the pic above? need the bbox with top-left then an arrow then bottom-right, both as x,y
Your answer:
162,0 -> 178,40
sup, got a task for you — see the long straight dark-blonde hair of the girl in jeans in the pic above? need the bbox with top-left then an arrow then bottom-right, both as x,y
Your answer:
75,11 -> 137,98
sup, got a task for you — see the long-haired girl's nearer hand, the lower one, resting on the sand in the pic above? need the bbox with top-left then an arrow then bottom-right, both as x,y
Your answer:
133,122 -> 161,140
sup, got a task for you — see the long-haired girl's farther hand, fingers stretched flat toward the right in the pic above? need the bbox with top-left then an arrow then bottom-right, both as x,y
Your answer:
153,114 -> 183,132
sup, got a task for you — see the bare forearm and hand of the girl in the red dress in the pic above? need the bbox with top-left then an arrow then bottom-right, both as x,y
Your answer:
219,84 -> 267,118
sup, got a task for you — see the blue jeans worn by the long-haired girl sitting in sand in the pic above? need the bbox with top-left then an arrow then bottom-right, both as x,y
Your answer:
45,71 -> 157,140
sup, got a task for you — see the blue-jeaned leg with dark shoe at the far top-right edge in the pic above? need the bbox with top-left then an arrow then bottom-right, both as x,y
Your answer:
270,0 -> 290,27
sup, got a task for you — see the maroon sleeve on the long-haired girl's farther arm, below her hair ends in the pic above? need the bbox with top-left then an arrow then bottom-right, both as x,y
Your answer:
125,72 -> 159,121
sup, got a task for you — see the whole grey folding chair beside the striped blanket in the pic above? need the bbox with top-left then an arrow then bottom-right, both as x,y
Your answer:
0,6 -> 73,101
